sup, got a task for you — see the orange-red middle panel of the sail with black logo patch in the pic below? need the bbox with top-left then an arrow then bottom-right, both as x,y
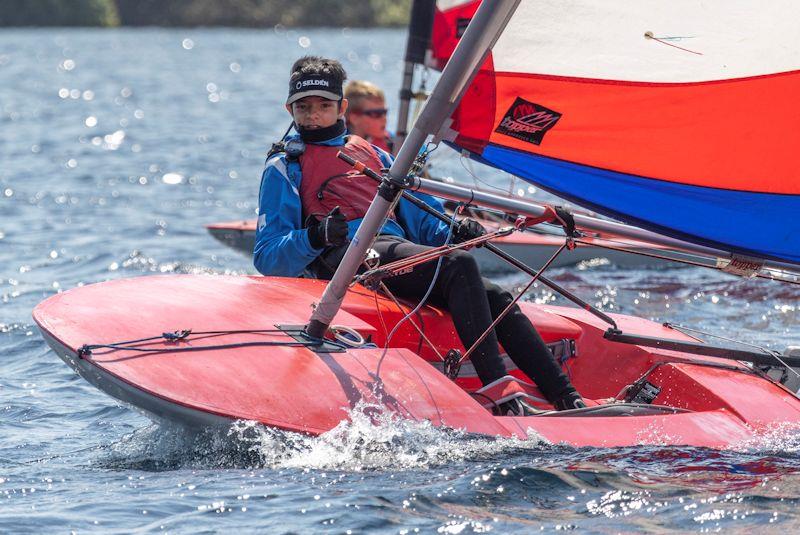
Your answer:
454,66 -> 800,194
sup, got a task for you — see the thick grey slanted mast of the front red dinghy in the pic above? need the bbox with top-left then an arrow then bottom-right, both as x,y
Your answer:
306,0 -> 521,338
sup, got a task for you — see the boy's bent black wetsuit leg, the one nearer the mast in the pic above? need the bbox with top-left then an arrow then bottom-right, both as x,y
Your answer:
372,236 -> 506,384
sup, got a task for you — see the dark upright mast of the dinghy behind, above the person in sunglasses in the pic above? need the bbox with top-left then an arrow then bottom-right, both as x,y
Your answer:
395,0 -> 436,153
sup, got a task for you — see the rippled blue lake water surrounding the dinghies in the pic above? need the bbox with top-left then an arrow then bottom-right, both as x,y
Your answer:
0,29 -> 800,533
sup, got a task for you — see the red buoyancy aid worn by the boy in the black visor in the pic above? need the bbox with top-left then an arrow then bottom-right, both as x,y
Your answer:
300,136 -> 383,221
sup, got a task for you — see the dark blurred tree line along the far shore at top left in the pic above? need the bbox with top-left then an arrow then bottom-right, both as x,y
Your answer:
0,0 -> 411,27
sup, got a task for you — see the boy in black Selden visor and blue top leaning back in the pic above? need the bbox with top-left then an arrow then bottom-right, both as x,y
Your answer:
254,56 -> 584,414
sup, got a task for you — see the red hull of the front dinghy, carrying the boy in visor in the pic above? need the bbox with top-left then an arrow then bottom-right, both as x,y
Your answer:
34,275 -> 800,448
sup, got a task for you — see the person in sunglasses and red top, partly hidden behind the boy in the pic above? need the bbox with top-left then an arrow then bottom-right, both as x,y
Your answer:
344,80 -> 394,154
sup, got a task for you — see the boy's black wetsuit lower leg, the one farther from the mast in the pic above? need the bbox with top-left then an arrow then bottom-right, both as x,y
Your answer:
483,279 -> 574,401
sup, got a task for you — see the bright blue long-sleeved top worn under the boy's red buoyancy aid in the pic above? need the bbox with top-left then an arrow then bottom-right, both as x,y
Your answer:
253,135 -> 449,277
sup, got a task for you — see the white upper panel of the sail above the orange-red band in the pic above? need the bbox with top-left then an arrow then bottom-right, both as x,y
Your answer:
493,0 -> 800,83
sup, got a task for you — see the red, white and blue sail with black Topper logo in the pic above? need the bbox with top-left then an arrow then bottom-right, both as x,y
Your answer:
431,0 -> 800,264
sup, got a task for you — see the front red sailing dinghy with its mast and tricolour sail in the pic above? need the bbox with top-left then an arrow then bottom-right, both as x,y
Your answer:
33,0 -> 800,448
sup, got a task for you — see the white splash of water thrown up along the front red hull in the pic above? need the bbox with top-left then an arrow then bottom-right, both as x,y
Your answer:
95,402 -> 543,472
